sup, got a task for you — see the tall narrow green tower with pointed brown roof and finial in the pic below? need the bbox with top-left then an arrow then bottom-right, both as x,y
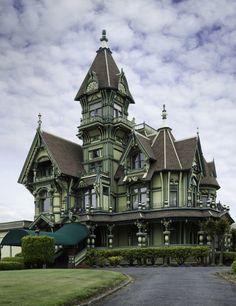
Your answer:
75,30 -> 134,209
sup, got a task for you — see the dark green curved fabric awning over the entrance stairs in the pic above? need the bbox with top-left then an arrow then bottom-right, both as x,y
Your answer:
1,223 -> 89,246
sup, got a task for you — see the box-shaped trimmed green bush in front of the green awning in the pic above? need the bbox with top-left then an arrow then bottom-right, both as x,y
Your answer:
22,236 -> 55,267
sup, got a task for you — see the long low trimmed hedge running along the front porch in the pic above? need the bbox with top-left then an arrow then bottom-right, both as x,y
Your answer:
86,246 -> 210,266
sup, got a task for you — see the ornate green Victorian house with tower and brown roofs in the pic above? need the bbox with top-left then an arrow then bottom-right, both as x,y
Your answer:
0,31 -> 233,256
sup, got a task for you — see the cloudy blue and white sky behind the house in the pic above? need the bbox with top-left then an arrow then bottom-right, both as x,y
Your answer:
0,0 -> 236,222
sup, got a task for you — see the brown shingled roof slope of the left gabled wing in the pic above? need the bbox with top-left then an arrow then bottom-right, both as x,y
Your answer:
40,131 -> 84,177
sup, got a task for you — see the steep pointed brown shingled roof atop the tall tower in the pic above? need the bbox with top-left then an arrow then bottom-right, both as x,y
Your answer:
75,30 -> 134,103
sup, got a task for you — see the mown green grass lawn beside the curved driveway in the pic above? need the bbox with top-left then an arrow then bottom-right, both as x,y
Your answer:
0,269 -> 126,306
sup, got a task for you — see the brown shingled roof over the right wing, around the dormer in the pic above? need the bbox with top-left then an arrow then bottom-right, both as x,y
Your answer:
115,127 -> 213,184
